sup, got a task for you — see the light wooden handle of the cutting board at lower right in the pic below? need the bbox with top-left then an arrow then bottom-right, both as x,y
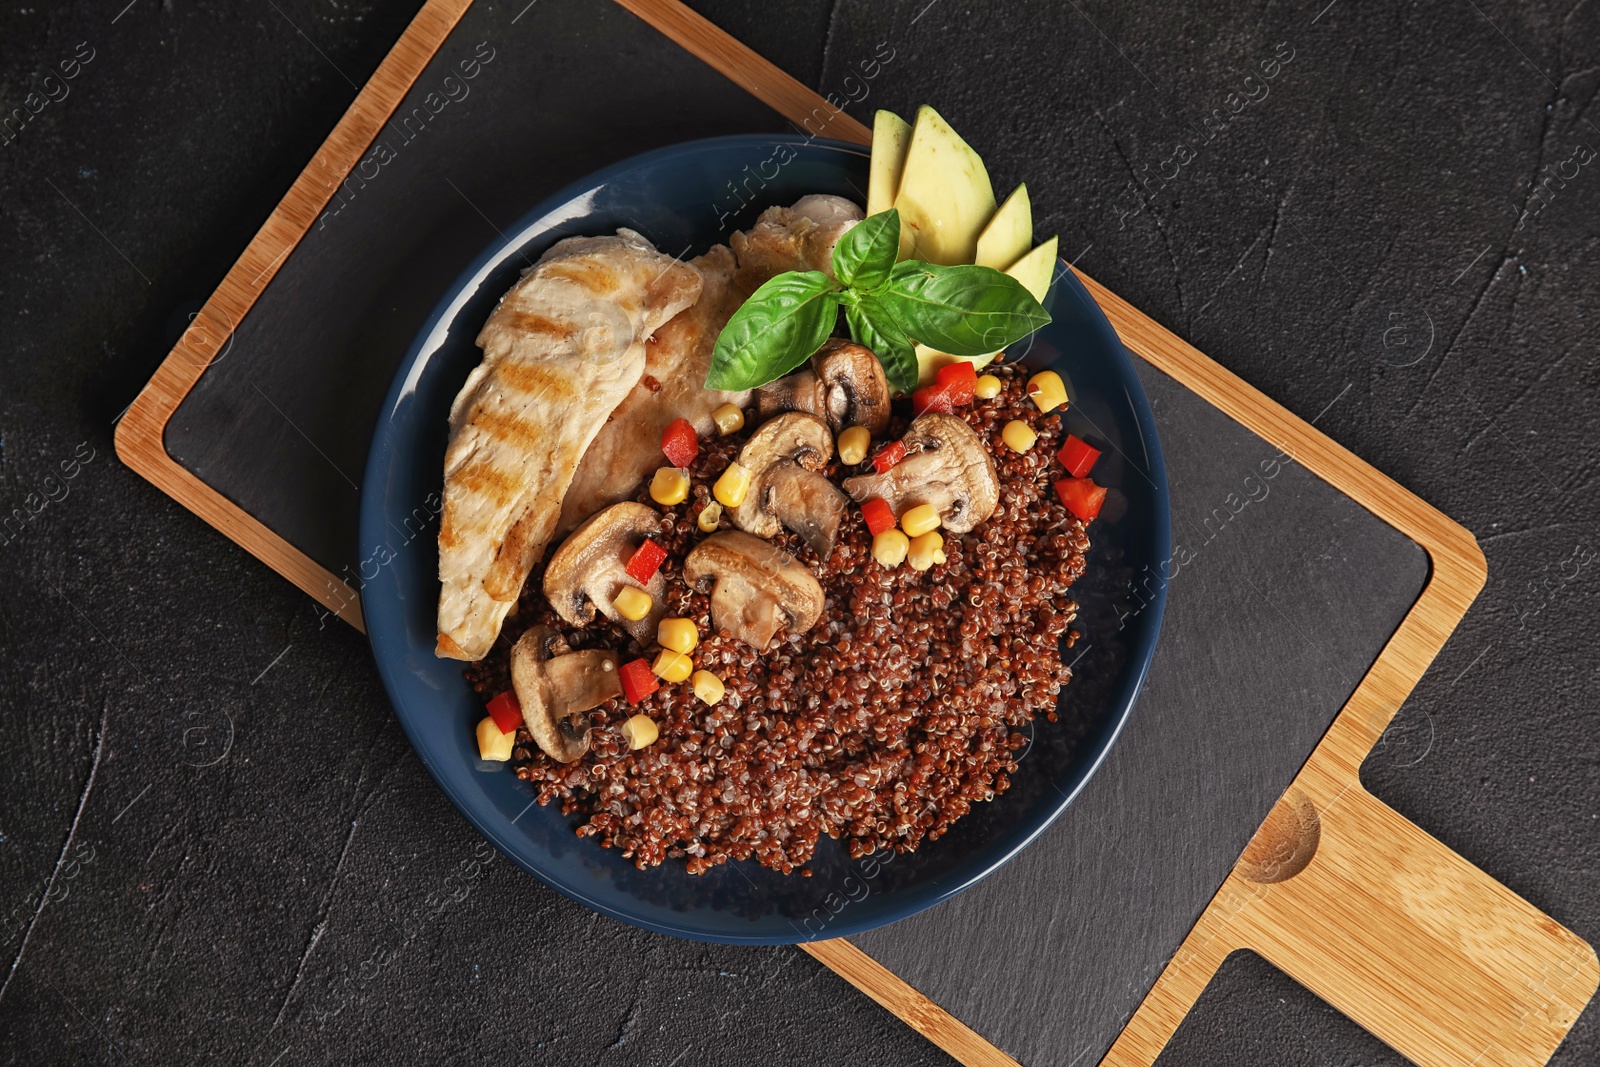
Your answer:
1229,784 -> 1600,1067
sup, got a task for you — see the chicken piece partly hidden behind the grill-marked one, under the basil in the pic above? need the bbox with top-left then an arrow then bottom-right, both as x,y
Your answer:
560,195 -> 861,531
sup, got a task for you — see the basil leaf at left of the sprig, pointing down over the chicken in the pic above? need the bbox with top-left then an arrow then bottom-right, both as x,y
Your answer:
706,270 -> 838,390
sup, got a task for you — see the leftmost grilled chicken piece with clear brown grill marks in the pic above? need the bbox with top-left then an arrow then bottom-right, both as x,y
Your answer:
437,230 -> 701,659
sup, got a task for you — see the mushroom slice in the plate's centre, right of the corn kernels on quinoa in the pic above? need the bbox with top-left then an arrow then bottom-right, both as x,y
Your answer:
683,530 -> 822,651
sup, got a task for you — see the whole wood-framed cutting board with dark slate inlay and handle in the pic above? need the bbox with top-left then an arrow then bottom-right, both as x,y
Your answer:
117,0 -> 1597,1067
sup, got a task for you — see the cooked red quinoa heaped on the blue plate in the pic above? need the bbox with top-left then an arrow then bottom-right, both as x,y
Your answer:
466,365 -> 1088,873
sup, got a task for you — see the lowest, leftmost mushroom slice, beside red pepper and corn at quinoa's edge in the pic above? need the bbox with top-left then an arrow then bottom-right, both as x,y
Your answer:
510,625 -> 622,763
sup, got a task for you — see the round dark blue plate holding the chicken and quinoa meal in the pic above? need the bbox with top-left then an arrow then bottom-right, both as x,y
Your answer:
360,136 -> 1171,944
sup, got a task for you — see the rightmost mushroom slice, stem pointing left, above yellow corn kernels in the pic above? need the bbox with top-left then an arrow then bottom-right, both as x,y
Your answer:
845,413 -> 1000,533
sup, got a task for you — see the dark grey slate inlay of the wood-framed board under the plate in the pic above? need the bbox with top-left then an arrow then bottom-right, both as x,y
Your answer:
120,0 -> 1592,1064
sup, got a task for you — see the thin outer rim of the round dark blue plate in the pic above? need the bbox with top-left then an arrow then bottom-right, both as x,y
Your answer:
358,133 -> 1171,945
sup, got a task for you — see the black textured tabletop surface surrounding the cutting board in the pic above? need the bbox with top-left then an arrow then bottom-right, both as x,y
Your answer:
0,0 -> 1600,1064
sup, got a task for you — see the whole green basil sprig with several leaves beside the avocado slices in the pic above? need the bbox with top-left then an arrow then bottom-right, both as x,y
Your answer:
706,208 -> 1050,392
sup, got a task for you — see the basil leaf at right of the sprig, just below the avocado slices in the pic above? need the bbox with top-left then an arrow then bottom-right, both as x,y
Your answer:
878,259 -> 1050,355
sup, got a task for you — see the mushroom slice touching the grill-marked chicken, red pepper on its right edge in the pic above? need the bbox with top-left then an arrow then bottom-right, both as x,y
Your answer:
544,501 -> 667,643
